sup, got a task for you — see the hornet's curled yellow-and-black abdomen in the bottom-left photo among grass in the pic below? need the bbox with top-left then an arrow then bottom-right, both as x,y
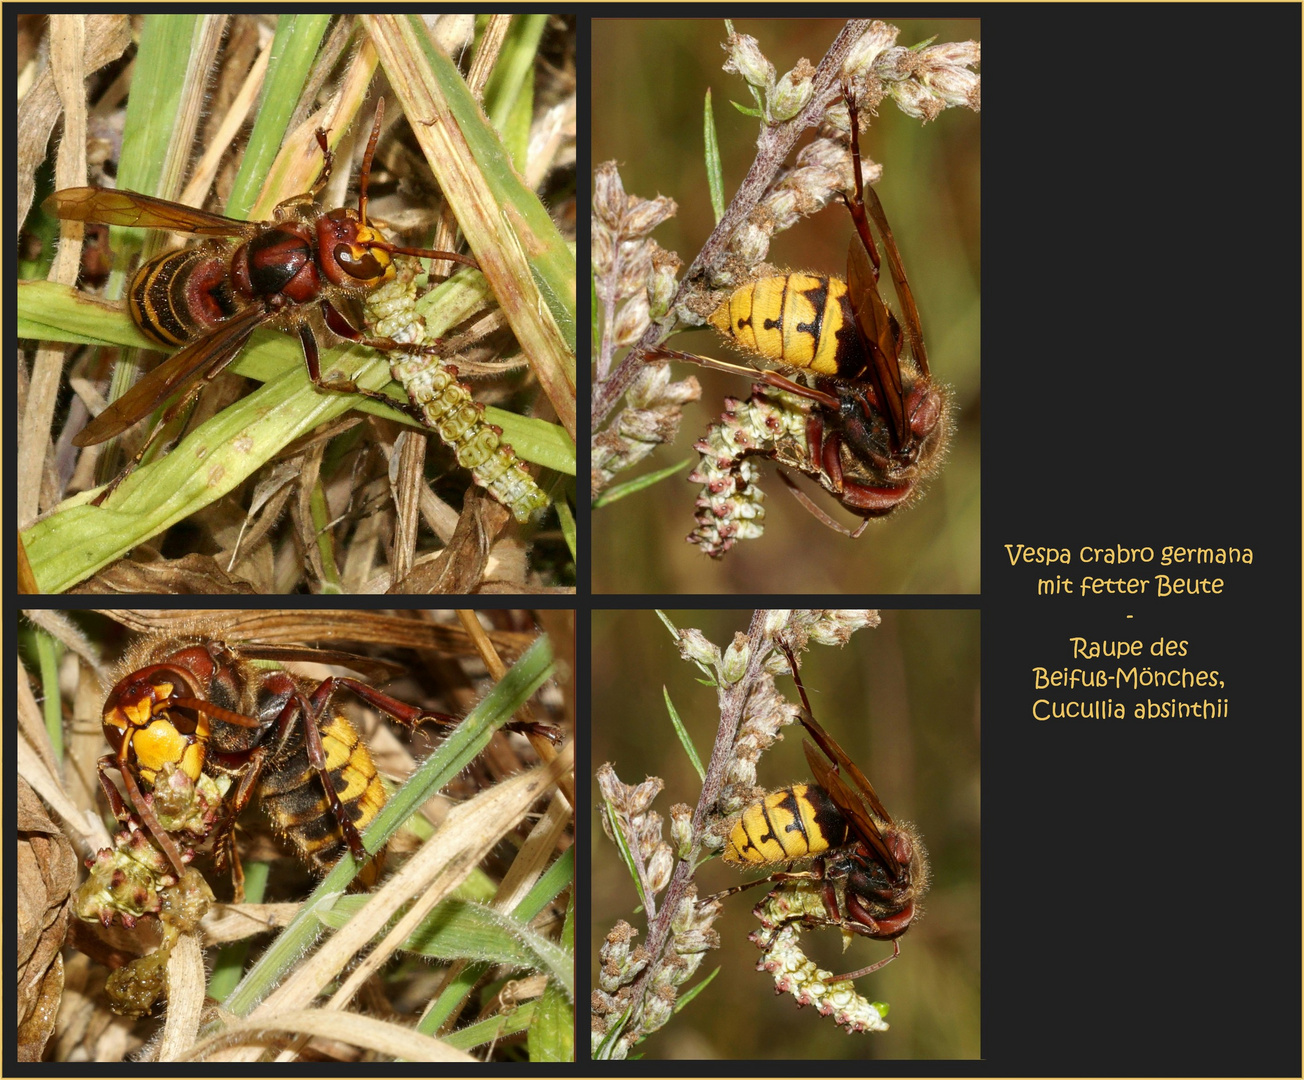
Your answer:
258,715 -> 385,884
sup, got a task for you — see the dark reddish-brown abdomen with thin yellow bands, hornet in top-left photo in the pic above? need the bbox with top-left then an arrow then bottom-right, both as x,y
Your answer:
126,244 -> 243,347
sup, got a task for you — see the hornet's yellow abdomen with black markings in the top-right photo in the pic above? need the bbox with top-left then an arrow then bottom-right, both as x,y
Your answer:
709,274 -> 865,378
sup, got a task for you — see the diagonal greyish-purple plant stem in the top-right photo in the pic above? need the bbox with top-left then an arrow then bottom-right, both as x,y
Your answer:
591,18 -> 871,427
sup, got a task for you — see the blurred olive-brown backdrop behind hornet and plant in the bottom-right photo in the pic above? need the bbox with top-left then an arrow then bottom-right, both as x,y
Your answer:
589,610 -> 981,1059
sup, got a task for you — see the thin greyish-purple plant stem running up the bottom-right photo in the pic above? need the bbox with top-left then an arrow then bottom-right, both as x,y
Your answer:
618,610 -> 772,1033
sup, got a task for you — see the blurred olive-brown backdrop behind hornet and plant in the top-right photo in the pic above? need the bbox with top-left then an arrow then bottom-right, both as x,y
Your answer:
592,18 -> 982,593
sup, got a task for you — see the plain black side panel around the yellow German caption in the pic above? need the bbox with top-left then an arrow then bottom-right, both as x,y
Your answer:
982,7 -> 1301,1076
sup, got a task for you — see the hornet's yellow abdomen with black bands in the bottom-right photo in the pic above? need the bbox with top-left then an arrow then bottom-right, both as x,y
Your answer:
725,784 -> 849,866
